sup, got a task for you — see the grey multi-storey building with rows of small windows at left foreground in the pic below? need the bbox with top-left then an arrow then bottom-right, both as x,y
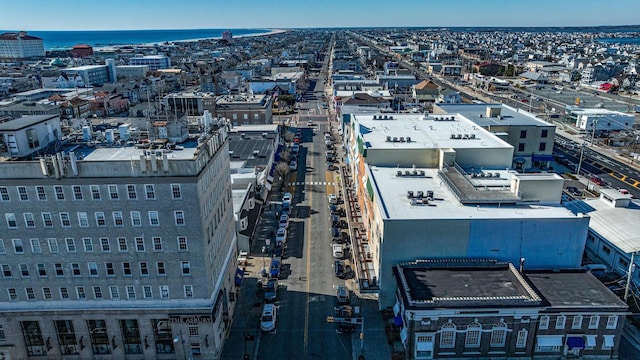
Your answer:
0,117 -> 242,359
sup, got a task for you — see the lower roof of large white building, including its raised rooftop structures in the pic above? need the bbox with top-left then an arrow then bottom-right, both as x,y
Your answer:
368,166 -> 582,220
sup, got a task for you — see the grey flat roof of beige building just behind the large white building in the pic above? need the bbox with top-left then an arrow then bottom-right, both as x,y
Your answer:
434,104 -> 554,128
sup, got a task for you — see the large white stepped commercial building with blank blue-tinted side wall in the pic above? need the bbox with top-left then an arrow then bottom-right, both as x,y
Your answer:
347,114 -> 589,308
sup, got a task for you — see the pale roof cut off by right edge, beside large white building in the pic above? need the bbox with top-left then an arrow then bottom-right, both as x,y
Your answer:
583,198 -> 640,253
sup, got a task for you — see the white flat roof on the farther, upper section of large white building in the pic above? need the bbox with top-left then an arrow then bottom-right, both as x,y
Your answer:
353,114 -> 512,149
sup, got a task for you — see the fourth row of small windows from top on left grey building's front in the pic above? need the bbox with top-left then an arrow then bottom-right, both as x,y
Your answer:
0,261 -> 191,279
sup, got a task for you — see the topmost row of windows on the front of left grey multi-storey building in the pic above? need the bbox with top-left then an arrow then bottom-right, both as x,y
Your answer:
0,184 -> 182,201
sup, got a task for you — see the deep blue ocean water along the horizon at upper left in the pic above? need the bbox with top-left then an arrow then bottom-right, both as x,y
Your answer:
0,29 -> 271,49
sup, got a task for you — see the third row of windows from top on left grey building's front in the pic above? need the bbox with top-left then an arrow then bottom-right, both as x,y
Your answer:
0,236 -> 189,254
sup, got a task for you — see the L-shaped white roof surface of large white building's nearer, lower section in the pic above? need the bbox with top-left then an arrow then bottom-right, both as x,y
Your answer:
369,166 -> 576,220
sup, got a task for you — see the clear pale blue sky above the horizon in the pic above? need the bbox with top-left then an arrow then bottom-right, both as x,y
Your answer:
0,0 -> 640,31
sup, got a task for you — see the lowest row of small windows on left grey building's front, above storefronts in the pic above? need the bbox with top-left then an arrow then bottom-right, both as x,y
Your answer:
7,285 -> 193,301
